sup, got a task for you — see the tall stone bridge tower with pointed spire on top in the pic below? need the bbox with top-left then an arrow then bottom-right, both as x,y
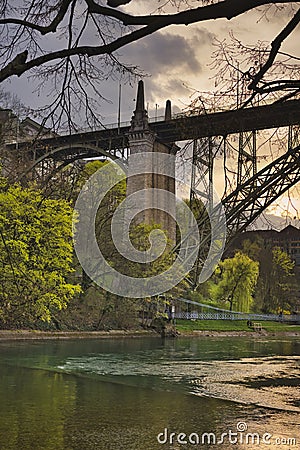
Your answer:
127,81 -> 177,242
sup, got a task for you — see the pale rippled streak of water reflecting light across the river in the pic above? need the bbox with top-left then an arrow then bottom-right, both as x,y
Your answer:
58,346 -> 300,412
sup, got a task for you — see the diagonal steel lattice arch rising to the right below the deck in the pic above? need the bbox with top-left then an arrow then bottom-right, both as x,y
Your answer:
185,145 -> 300,287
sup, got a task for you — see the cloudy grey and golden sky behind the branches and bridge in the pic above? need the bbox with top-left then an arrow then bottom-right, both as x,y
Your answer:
3,0 -> 300,225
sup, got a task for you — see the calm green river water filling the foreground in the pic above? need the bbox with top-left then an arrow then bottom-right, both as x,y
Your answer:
0,337 -> 300,450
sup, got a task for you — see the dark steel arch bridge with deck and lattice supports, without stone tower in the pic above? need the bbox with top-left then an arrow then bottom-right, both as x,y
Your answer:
2,95 -> 300,282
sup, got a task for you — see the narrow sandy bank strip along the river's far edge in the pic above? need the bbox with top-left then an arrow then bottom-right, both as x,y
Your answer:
0,330 -> 300,342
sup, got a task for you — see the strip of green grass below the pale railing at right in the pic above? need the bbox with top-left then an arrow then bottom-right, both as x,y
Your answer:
176,320 -> 300,333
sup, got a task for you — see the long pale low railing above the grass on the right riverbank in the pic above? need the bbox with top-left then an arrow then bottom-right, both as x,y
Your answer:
174,311 -> 300,323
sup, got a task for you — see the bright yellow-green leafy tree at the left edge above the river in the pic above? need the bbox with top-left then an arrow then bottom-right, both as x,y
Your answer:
0,178 -> 80,326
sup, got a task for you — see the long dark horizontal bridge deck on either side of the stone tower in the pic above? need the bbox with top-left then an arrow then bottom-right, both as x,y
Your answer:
7,100 -> 300,155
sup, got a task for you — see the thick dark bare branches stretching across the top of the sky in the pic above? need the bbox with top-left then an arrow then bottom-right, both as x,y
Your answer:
0,0 -> 298,82
